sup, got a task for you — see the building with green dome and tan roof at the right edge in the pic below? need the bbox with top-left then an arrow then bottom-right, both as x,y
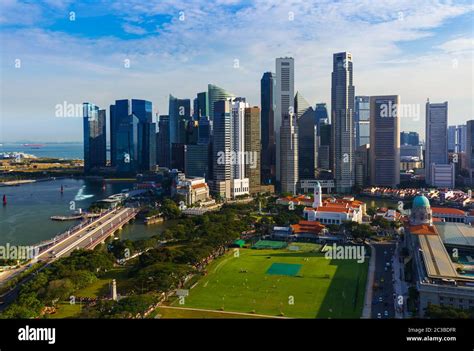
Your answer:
405,195 -> 474,317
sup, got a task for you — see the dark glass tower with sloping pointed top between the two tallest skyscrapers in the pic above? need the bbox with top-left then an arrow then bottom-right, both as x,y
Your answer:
295,92 -> 319,180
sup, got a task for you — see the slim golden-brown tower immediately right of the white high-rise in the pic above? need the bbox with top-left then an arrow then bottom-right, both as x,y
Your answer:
244,106 -> 261,194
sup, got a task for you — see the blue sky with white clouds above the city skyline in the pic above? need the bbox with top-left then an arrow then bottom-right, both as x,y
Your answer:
0,0 -> 474,143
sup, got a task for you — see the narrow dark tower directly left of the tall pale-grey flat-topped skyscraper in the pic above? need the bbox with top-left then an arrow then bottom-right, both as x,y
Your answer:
260,72 -> 276,184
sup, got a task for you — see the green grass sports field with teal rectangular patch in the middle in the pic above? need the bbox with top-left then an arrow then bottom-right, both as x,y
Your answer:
172,243 -> 368,318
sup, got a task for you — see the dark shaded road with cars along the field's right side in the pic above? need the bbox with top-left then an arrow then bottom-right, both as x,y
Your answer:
371,241 -> 395,319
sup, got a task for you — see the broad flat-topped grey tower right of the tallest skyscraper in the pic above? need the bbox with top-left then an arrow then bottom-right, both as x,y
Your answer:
370,95 -> 400,188
